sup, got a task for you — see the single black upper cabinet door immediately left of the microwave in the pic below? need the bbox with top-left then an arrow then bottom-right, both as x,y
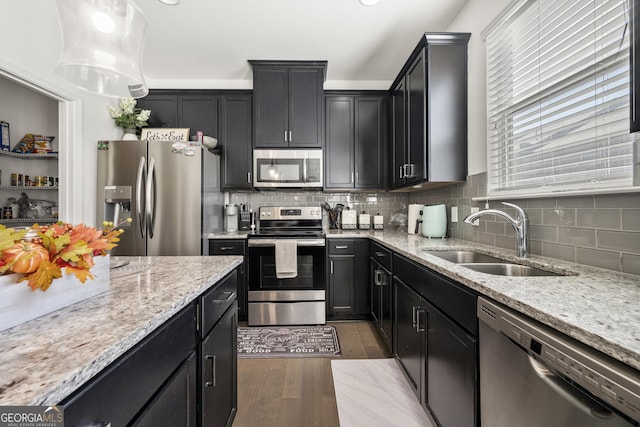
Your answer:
218,95 -> 253,190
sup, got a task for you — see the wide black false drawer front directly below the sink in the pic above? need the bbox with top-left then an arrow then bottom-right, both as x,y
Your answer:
393,254 -> 478,335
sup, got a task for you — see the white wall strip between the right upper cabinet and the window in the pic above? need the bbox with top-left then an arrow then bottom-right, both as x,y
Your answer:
447,0 -> 511,175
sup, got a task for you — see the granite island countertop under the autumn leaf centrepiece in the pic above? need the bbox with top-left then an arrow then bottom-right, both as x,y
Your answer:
0,256 -> 242,406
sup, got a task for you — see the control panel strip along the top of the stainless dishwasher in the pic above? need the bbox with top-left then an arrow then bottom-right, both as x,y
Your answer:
478,298 -> 640,422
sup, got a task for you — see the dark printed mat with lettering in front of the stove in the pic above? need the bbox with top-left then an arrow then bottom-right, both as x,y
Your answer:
238,326 -> 340,357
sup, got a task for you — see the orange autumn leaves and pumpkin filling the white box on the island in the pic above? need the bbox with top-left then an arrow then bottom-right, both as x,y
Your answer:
0,222 -> 130,291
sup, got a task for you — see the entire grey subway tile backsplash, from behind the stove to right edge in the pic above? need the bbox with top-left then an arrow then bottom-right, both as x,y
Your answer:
230,173 -> 640,275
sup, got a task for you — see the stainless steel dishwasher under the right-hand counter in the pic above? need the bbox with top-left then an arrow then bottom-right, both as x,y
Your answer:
478,298 -> 640,427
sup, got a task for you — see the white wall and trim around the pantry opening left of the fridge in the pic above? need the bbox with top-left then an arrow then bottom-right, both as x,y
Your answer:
0,0 -> 121,225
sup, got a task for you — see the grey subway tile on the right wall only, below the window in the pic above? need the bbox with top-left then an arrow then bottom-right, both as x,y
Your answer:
408,173 -> 640,275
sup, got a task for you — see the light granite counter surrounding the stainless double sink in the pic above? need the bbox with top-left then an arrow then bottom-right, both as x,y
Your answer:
327,230 -> 640,369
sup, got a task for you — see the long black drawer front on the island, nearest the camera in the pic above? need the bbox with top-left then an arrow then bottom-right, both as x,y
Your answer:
62,304 -> 196,426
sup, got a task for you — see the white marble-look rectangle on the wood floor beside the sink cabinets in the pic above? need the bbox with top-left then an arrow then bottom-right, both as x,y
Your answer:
331,359 -> 433,427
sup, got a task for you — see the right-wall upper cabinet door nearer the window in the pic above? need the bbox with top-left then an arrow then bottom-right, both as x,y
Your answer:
407,49 -> 426,184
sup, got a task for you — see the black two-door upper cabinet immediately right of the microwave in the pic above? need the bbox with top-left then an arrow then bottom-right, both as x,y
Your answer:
324,91 -> 387,190
